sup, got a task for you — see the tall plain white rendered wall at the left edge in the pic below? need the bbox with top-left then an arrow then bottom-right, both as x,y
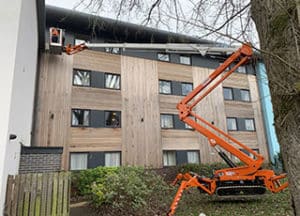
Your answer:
0,0 -> 38,215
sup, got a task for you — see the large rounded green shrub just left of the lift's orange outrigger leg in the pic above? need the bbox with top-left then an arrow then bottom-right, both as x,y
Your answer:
92,167 -> 172,215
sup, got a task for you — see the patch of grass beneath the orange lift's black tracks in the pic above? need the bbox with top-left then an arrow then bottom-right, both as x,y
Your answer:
176,189 -> 292,216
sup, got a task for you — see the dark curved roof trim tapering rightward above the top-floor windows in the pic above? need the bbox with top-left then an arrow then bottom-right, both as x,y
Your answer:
46,5 -> 215,44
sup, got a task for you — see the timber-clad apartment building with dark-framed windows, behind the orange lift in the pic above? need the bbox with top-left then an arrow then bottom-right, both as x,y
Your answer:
33,7 -> 269,170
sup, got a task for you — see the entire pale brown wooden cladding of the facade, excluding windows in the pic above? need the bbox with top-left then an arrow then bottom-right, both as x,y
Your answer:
34,50 -> 267,168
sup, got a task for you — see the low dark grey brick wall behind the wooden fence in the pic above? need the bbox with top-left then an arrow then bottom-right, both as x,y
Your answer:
19,147 -> 63,174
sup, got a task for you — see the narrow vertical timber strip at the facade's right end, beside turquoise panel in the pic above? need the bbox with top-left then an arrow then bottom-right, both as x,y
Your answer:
248,75 -> 269,162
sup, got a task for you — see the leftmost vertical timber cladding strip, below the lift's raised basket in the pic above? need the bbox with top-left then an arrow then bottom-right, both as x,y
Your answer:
33,53 -> 73,167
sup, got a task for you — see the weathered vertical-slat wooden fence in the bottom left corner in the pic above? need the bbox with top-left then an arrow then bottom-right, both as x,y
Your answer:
4,172 -> 71,216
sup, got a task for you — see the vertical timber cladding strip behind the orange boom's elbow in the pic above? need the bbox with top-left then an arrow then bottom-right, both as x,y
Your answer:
193,67 -> 226,163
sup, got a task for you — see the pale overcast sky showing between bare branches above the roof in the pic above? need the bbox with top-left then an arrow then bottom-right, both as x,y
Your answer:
46,0 -> 259,46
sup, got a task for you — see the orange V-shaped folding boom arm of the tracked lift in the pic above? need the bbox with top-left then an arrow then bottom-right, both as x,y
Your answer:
177,44 -> 263,176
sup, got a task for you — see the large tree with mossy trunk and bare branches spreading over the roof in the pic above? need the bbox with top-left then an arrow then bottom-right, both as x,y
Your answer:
75,0 -> 300,215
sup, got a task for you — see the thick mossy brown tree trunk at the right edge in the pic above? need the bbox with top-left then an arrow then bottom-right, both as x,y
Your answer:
251,0 -> 300,216
